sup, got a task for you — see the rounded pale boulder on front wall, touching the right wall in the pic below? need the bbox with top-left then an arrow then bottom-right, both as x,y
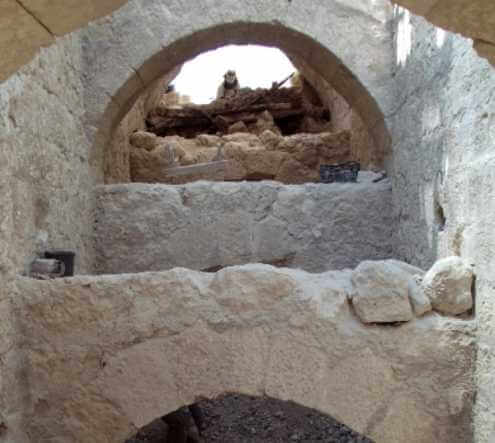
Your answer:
421,256 -> 473,315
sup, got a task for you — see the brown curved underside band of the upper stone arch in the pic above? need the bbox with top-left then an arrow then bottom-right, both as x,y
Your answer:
101,22 -> 390,183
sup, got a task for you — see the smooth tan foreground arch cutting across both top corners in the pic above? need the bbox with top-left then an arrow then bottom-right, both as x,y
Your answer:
0,0 -> 495,88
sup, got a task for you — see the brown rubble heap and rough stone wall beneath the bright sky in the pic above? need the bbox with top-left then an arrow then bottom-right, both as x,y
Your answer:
126,84 -> 355,184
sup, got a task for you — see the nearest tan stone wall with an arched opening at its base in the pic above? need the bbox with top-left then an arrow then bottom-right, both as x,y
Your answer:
11,260 -> 474,443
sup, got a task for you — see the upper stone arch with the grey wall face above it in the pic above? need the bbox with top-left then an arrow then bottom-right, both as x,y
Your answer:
76,1 -> 394,183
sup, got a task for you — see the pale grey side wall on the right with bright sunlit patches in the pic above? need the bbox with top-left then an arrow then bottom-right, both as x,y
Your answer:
391,13 -> 495,443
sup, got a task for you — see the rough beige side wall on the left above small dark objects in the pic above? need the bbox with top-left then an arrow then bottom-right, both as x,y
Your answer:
0,35 -> 97,273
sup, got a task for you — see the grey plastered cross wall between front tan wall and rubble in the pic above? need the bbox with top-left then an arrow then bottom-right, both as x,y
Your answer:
95,172 -> 395,274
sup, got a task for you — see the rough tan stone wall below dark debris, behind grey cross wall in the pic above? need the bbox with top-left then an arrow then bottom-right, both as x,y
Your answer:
130,130 -> 352,184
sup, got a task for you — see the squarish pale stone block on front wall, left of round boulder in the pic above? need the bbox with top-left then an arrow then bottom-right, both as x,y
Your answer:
350,260 -> 420,323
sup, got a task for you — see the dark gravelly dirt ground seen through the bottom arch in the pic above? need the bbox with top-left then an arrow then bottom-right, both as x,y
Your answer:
126,394 -> 373,443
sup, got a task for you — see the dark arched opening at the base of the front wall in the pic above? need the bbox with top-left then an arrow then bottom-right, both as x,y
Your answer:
125,393 -> 372,443
